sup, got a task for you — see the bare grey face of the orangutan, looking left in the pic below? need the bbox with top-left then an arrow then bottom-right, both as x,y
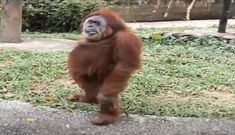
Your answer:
83,15 -> 107,40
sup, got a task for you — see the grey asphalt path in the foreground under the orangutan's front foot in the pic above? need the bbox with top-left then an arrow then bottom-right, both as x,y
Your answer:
0,101 -> 235,135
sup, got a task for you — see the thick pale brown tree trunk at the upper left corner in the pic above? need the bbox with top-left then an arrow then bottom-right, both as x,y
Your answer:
0,0 -> 22,43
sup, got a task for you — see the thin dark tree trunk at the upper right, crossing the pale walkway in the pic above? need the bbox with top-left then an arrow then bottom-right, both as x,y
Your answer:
218,0 -> 232,33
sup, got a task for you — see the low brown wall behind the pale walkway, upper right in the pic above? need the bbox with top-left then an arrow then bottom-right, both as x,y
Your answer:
111,0 -> 235,22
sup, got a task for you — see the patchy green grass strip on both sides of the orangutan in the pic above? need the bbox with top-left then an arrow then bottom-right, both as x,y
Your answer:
0,37 -> 235,119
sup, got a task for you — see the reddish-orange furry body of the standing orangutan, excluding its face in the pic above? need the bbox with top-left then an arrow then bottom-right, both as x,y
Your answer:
68,9 -> 143,125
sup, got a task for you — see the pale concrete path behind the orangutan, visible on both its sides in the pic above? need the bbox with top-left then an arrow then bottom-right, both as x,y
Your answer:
0,19 -> 235,52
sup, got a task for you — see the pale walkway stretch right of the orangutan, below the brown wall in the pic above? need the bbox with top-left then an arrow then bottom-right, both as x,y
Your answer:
128,19 -> 235,40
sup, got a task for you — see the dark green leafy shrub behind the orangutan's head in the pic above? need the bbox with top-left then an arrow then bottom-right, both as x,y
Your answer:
23,0 -> 107,32
